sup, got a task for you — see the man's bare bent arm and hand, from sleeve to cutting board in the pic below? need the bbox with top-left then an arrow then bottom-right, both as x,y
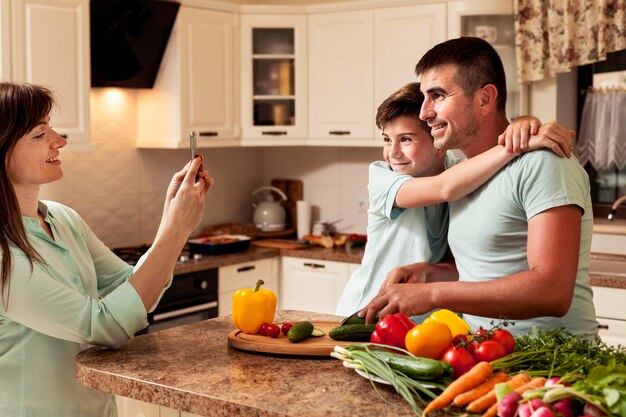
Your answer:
361,205 -> 581,322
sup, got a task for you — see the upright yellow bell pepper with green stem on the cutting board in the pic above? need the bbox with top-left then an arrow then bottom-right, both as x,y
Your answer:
233,279 -> 276,334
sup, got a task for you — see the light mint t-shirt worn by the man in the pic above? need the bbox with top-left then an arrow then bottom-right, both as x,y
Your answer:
448,150 -> 598,338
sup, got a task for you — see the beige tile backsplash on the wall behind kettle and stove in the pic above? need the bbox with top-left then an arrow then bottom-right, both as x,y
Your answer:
41,89 -> 382,247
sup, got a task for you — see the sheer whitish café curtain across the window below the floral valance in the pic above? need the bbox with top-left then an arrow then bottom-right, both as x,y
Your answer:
574,88 -> 626,170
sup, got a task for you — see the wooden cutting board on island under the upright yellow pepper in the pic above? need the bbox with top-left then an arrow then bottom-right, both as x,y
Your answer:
228,321 -> 358,356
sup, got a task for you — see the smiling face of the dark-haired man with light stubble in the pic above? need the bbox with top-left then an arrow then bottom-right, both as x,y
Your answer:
420,65 -> 479,150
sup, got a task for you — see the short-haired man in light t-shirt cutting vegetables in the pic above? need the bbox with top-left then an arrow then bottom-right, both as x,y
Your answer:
361,37 -> 597,338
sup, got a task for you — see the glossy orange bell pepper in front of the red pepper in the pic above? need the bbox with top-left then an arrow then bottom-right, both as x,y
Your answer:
404,321 -> 452,359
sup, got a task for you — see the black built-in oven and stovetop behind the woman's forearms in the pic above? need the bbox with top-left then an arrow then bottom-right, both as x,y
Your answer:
113,245 -> 218,334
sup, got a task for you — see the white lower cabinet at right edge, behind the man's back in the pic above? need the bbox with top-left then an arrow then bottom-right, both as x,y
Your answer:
592,287 -> 626,346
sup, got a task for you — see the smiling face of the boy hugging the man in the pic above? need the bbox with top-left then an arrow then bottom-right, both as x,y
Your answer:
383,116 -> 445,177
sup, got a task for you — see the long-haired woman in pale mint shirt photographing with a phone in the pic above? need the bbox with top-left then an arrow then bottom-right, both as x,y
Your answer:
0,83 -> 213,417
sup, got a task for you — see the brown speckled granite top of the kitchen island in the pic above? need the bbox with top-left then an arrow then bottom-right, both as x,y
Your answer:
76,310 -> 415,416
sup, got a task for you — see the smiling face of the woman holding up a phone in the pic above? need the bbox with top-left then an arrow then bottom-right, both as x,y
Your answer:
7,117 -> 67,187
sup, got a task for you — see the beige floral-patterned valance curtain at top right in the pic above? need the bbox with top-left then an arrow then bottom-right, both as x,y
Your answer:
515,0 -> 626,83
